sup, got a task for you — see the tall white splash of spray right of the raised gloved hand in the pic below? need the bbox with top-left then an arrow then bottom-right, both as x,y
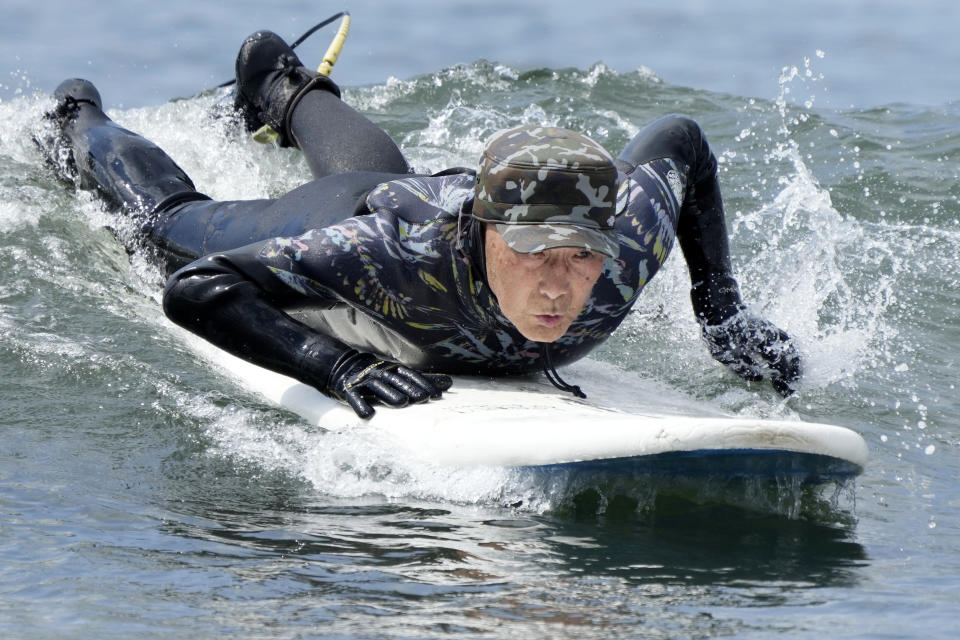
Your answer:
731,52 -> 903,390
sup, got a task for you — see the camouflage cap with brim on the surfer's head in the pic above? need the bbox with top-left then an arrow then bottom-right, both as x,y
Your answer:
472,125 -> 620,258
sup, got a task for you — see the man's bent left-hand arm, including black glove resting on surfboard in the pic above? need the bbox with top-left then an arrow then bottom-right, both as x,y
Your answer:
163,245 -> 451,418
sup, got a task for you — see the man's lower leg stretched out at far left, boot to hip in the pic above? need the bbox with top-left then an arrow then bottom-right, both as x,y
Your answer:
38,79 -> 404,273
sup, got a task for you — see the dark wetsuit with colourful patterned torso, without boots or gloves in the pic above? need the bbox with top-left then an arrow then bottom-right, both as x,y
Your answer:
50,82 -> 740,396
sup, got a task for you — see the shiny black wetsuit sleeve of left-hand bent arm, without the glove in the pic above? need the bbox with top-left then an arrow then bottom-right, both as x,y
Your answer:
163,243 -> 352,392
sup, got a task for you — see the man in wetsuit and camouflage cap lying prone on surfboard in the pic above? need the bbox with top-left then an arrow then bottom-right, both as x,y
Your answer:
42,32 -> 800,417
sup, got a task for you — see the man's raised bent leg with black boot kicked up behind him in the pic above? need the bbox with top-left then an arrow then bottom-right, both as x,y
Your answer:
236,31 -> 410,178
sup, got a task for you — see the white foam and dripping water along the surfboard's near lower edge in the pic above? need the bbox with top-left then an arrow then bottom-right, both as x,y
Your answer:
197,410 -> 853,519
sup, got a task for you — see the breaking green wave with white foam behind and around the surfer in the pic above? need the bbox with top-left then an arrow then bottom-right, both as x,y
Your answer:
0,61 -> 960,509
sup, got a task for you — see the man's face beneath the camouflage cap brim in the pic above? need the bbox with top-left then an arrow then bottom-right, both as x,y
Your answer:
484,225 -> 605,342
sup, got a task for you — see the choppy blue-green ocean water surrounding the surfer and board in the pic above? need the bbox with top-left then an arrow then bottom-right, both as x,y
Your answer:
0,0 -> 960,639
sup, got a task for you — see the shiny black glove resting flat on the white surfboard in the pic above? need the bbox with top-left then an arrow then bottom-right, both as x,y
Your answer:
327,349 -> 453,419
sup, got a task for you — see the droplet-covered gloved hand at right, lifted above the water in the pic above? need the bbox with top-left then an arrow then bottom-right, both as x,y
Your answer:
701,311 -> 800,396
